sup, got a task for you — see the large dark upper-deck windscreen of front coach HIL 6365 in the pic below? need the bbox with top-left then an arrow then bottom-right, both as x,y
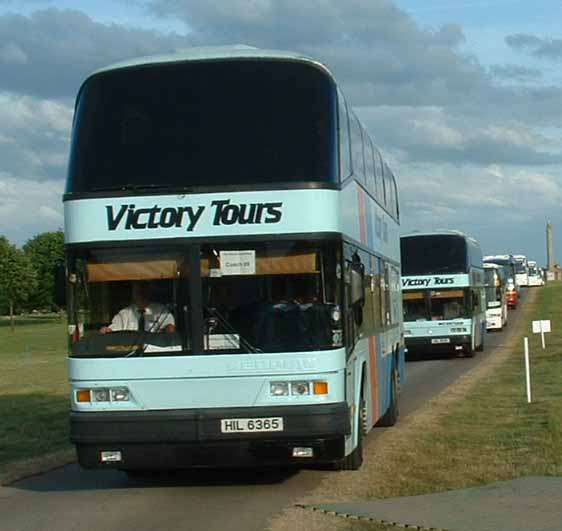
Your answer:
66,60 -> 337,193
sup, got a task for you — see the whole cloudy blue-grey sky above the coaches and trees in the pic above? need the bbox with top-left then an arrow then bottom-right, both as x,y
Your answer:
0,0 -> 562,264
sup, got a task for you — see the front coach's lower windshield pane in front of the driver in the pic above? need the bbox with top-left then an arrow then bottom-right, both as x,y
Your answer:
68,248 -> 191,357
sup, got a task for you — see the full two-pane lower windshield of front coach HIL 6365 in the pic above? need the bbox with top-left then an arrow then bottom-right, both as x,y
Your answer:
68,241 -> 343,358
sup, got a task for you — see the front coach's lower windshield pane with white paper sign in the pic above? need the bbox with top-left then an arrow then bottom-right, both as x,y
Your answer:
201,242 -> 343,353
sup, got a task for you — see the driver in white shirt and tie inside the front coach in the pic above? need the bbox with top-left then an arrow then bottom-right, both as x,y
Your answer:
100,282 -> 176,334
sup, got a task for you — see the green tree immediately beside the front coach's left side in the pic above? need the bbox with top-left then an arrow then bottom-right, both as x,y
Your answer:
23,230 -> 64,310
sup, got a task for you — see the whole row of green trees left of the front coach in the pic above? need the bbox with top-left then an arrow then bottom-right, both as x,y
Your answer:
0,230 -> 64,324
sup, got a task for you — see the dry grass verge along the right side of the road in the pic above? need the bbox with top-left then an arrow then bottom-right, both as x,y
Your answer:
271,283 -> 562,531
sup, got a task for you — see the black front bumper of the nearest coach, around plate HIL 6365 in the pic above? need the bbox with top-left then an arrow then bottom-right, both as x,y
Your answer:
70,403 -> 351,469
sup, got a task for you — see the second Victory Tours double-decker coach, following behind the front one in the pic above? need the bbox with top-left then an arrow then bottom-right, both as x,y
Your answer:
401,230 -> 486,356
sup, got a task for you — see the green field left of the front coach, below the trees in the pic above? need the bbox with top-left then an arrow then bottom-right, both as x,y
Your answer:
0,315 -> 70,475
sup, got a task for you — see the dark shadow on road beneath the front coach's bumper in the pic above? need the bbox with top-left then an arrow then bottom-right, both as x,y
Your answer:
11,465 -> 299,492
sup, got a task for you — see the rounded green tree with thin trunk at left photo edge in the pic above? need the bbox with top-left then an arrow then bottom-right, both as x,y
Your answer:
0,237 -> 37,331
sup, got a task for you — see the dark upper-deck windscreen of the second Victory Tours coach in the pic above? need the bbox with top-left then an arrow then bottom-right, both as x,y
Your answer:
400,235 -> 468,276
